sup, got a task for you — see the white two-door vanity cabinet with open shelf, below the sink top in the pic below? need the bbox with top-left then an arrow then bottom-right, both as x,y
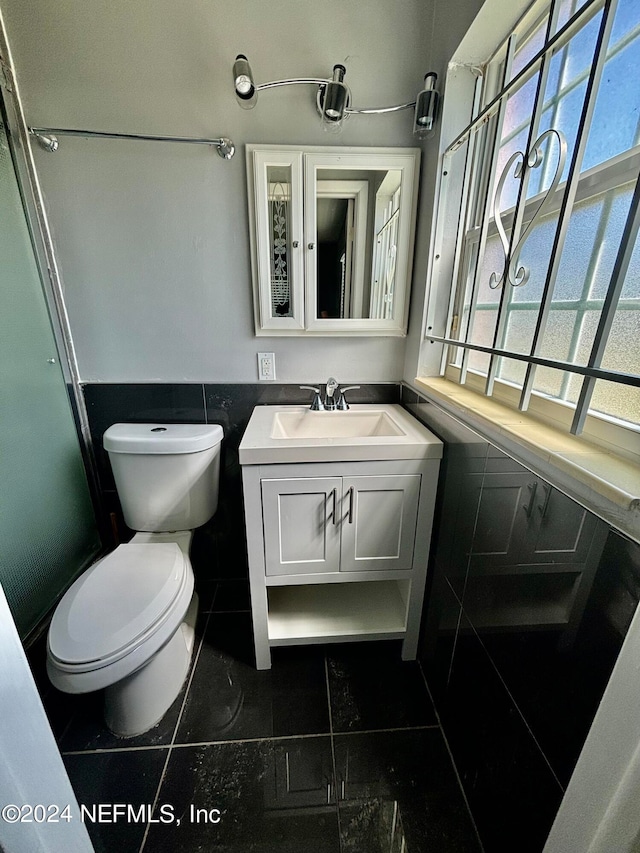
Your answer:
242,458 -> 440,669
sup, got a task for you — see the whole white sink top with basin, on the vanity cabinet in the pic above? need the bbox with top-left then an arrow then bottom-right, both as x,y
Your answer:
239,403 -> 442,465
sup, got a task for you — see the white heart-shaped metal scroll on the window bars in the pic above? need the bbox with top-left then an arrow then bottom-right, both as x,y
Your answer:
489,130 -> 567,290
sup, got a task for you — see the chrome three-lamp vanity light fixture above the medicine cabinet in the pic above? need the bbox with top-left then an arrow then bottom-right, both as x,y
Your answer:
233,53 -> 439,138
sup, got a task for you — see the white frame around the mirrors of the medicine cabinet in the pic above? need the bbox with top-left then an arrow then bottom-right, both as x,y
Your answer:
246,145 -> 420,336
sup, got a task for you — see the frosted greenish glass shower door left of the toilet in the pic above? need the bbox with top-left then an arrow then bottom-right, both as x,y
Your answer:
0,120 -> 100,638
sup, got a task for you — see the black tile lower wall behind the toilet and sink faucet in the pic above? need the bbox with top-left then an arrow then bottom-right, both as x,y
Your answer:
83,383 -> 400,578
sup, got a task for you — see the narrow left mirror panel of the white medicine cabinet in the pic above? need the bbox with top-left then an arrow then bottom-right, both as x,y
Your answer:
267,165 -> 293,317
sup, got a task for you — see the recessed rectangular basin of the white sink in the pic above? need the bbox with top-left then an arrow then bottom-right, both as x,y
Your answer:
271,409 -> 406,440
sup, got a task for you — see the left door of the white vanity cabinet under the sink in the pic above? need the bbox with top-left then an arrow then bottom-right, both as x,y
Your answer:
262,477 -> 342,575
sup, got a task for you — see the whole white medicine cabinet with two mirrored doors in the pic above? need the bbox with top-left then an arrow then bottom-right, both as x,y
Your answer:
247,145 -> 420,335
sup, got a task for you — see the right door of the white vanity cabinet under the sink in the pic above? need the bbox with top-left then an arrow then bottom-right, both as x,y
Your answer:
340,474 -> 421,572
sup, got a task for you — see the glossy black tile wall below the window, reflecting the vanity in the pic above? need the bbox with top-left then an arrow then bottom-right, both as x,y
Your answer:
402,387 -> 640,853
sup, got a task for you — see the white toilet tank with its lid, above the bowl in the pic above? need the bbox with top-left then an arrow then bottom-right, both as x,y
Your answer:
104,424 -> 223,532
